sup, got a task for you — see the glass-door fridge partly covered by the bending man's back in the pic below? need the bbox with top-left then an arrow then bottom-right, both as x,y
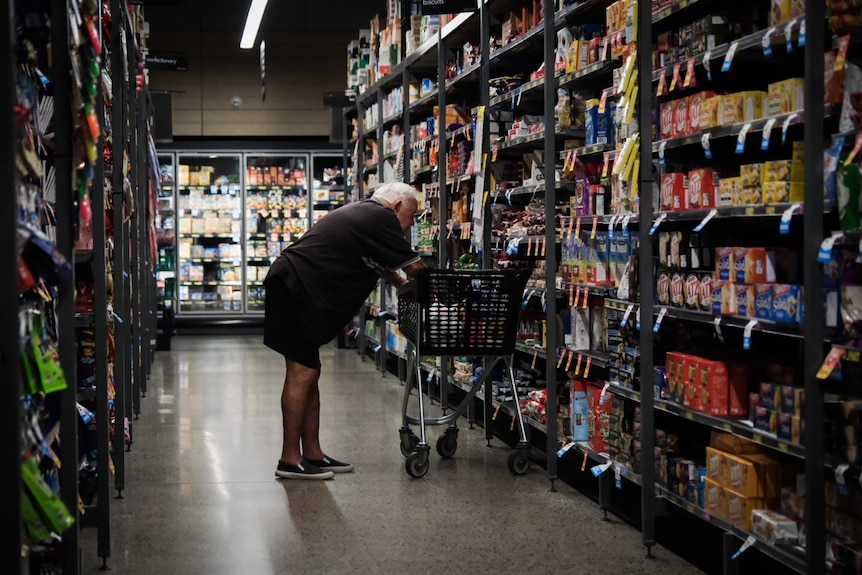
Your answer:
245,154 -> 311,313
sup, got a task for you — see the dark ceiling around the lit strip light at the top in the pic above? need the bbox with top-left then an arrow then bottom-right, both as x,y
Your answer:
144,0 -> 386,34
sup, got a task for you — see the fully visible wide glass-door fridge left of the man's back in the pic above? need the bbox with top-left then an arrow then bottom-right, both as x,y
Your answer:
177,154 -> 243,314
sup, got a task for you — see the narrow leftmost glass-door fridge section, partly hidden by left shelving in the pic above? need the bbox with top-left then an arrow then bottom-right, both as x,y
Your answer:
155,154 -> 177,335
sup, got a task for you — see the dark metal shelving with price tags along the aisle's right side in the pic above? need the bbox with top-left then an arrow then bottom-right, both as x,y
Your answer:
340,0 -> 859,573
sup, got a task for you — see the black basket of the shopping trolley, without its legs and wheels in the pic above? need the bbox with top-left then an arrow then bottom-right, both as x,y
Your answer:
398,269 -> 530,356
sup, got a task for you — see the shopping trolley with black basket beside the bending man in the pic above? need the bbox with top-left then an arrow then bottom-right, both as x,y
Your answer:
398,269 -> 530,477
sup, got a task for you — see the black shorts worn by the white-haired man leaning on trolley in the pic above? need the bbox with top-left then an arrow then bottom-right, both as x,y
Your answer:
263,276 -> 320,369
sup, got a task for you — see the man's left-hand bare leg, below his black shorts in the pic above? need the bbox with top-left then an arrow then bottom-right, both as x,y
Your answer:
281,359 -> 320,465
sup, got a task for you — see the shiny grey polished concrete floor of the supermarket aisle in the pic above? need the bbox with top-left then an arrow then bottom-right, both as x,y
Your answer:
81,336 -> 700,575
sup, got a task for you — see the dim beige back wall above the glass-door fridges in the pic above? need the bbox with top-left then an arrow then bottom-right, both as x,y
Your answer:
150,29 -> 356,137
